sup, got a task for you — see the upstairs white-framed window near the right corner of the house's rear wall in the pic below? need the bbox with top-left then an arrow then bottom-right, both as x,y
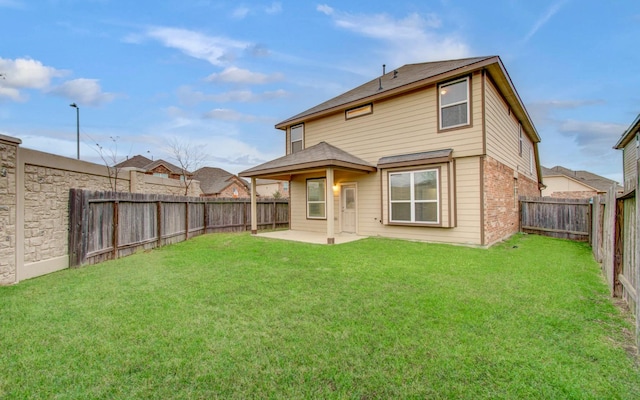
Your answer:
438,78 -> 469,129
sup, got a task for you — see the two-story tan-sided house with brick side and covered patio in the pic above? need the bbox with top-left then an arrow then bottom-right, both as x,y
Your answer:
240,56 -> 542,246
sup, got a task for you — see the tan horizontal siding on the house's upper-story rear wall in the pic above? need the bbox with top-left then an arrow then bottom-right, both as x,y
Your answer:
305,76 -> 482,164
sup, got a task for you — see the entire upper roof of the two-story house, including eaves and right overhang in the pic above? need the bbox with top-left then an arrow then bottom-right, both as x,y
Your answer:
275,56 -> 540,143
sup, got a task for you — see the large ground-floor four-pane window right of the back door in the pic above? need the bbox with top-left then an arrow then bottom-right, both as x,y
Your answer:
389,169 -> 440,224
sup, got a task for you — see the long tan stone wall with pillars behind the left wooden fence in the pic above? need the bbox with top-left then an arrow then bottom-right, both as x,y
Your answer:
0,135 -> 201,285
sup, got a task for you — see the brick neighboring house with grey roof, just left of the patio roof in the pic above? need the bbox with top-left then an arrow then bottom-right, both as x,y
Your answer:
193,167 -> 251,199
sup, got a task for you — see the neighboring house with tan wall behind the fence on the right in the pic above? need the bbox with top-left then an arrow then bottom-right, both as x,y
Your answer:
542,166 -> 622,199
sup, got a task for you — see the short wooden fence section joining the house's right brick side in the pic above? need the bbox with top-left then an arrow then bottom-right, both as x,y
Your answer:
520,196 -> 591,242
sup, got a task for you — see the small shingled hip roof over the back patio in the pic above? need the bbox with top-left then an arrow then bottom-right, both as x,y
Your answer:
239,142 -> 377,177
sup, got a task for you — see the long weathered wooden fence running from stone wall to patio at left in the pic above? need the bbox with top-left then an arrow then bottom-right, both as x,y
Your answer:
69,189 -> 289,267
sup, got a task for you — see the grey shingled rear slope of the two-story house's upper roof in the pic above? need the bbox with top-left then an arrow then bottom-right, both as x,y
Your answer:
276,56 -> 497,128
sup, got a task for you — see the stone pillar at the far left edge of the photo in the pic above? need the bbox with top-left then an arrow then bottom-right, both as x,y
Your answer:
0,135 -> 20,284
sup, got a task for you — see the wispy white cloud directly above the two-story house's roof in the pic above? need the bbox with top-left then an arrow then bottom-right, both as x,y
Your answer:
316,4 -> 470,65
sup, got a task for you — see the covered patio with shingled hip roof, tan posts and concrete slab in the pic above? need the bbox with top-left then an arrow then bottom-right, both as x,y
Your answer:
239,142 -> 377,244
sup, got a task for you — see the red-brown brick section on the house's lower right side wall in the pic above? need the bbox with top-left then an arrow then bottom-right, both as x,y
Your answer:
483,157 -> 540,245
